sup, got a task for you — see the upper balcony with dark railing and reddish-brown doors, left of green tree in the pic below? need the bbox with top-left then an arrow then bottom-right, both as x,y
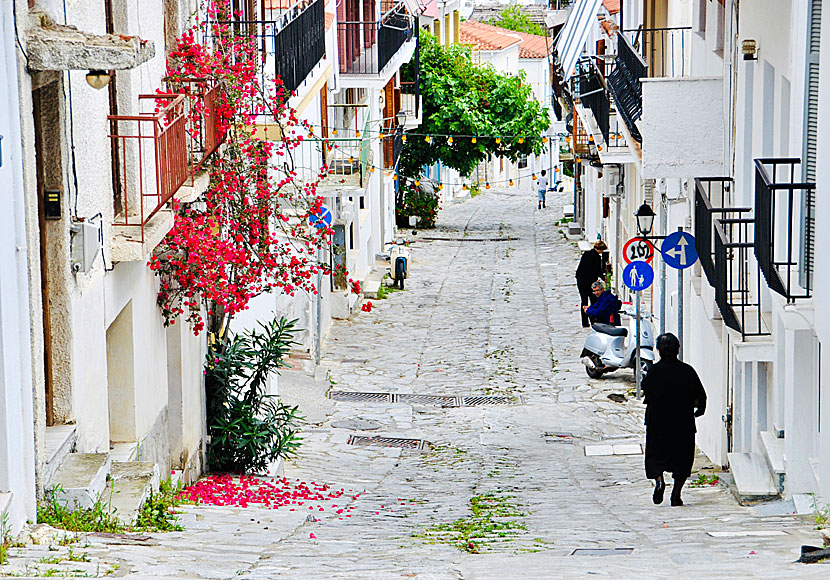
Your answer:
337,3 -> 417,75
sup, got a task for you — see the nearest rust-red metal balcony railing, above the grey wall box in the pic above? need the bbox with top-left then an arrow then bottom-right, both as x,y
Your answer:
107,94 -> 189,243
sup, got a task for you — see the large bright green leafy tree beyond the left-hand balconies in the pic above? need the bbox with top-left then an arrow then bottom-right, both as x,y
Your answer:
398,31 -> 550,179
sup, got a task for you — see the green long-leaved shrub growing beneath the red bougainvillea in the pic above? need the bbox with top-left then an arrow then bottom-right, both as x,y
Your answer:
205,318 -> 302,473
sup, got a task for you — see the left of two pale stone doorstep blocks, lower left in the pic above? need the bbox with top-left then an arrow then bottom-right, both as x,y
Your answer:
47,453 -> 111,508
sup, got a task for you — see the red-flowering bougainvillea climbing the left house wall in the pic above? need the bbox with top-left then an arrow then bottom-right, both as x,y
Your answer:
149,0 -> 332,343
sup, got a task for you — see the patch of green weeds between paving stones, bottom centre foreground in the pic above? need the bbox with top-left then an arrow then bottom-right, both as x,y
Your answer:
415,491 -> 527,554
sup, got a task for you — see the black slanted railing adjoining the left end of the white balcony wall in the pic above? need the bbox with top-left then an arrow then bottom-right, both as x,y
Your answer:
606,33 -> 648,141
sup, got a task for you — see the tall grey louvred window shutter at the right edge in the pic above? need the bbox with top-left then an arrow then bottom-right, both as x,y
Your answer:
798,0 -> 821,288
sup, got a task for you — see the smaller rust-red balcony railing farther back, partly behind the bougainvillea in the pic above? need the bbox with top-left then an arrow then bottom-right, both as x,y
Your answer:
165,78 -> 227,175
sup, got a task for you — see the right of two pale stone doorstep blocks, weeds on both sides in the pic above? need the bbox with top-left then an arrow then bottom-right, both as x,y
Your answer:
103,461 -> 159,524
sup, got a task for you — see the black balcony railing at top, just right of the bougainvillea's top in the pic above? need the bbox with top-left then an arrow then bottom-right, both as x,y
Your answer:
211,0 -> 326,94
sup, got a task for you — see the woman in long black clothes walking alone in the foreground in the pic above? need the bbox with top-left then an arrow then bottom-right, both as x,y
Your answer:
643,333 -> 706,506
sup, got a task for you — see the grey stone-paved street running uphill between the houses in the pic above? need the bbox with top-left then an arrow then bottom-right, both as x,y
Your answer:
3,192 -> 830,580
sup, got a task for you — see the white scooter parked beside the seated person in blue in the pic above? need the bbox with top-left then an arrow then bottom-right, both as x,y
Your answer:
581,311 -> 655,379
